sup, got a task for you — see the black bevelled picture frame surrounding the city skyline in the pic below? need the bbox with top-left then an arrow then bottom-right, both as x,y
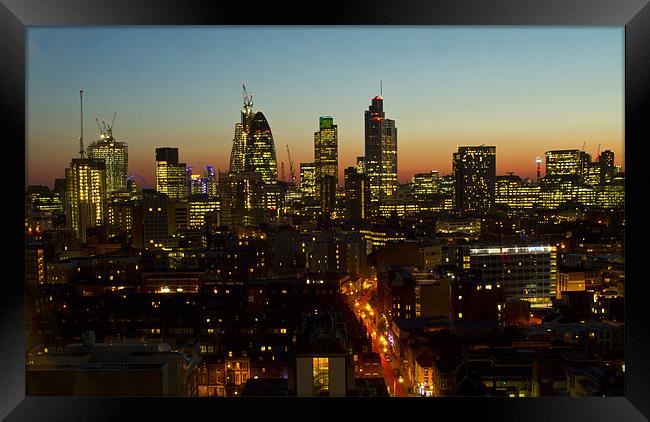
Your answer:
0,0 -> 650,422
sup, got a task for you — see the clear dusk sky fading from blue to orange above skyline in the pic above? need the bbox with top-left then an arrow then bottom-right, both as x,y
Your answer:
26,26 -> 624,187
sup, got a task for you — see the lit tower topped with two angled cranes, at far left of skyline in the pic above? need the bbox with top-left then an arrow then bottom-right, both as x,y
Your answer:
88,128 -> 129,194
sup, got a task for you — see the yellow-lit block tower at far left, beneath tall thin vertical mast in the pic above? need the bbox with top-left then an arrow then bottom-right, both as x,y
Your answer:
65,158 -> 107,243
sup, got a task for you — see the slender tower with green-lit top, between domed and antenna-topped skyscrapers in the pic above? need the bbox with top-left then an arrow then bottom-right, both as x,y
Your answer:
314,116 -> 338,214
